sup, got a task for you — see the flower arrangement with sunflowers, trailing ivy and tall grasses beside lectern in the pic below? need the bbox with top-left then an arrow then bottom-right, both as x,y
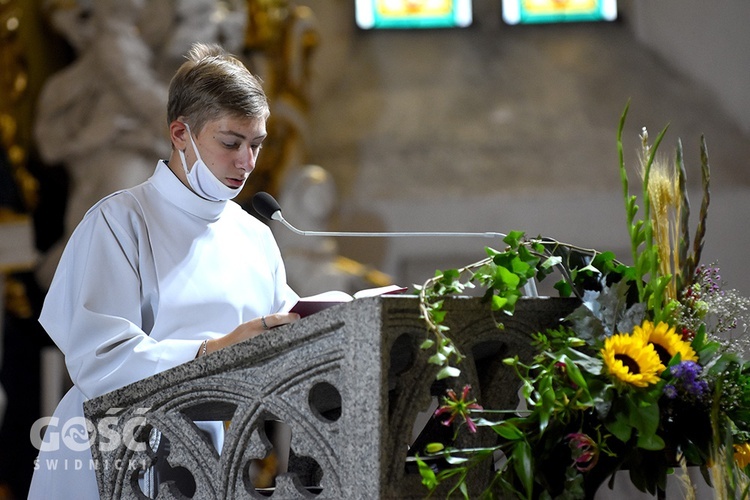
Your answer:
417,106 -> 750,499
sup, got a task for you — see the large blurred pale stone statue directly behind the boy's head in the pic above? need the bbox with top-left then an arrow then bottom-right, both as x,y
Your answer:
34,0 -> 250,287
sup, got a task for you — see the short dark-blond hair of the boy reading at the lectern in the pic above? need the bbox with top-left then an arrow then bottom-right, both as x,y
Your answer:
167,43 -> 269,134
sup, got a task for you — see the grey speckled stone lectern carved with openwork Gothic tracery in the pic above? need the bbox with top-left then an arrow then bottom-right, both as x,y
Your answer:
85,296 -> 577,500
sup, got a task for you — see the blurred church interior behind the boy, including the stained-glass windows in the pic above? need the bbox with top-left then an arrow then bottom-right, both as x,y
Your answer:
0,0 -> 750,499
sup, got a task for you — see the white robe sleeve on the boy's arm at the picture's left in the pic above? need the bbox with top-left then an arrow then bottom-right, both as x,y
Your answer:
39,202 -> 202,398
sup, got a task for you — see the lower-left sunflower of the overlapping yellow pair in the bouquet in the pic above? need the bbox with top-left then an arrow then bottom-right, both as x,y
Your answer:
601,334 -> 664,387
